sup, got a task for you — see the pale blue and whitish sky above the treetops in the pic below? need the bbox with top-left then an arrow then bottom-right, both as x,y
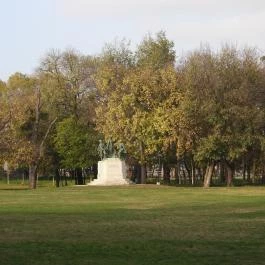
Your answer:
0,0 -> 265,81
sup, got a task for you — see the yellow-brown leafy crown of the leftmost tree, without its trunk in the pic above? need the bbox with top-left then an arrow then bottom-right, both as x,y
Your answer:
0,73 -> 41,165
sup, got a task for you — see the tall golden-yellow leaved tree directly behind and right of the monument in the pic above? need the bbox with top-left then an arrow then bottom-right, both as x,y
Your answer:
96,33 -> 175,183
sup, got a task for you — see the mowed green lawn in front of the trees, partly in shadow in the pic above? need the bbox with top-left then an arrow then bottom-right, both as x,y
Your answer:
0,185 -> 265,265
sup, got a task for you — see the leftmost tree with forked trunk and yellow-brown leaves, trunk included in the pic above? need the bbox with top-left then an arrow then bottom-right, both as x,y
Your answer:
0,73 -> 56,189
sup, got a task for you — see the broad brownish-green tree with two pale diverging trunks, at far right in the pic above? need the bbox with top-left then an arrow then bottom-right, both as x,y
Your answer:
177,46 -> 263,187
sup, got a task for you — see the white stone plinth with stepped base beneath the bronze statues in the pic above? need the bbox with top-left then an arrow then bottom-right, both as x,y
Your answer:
89,158 -> 130,185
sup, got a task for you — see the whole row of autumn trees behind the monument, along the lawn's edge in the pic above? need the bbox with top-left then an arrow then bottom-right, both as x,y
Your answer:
0,32 -> 265,188
